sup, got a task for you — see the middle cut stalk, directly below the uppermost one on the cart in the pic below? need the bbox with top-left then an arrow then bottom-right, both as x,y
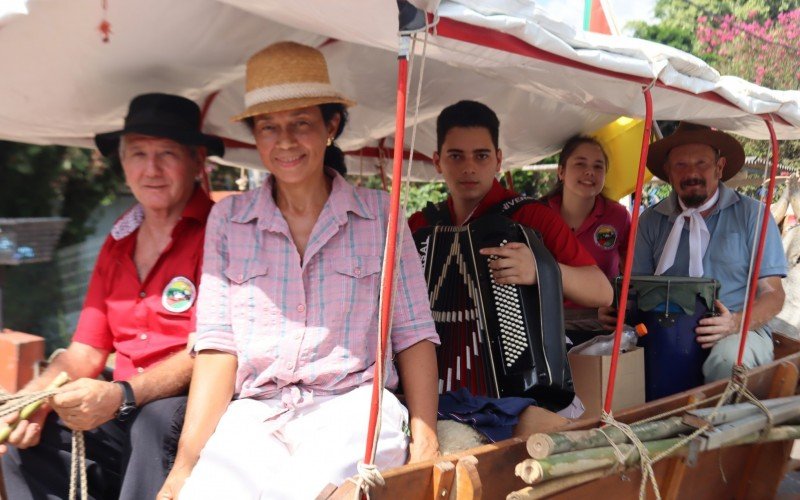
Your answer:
514,438 -> 680,484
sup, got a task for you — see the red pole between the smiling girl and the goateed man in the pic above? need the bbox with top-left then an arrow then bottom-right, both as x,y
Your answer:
603,88 -> 653,413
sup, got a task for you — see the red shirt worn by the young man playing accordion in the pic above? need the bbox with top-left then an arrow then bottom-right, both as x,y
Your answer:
408,180 -> 595,267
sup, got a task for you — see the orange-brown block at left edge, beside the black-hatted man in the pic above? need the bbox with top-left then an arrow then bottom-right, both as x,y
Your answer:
0,329 -> 44,393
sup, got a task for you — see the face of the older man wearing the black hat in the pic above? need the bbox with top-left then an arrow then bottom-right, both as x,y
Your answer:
119,134 -> 204,214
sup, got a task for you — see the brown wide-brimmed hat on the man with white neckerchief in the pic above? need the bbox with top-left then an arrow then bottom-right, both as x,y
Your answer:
647,122 -> 745,182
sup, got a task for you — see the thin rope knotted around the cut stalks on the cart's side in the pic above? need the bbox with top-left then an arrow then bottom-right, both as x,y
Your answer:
599,365 -> 774,500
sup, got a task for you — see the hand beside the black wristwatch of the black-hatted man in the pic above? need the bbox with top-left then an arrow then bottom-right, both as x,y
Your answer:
50,378 -> 124,431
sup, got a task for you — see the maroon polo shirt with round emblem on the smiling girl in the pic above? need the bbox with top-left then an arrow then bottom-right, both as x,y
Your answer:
547,193 -> 631,283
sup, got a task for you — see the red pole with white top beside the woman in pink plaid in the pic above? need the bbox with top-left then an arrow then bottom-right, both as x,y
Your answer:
364,35 -> 410,464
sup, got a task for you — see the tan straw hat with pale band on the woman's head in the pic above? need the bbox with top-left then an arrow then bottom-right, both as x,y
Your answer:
232,42 -> 355,121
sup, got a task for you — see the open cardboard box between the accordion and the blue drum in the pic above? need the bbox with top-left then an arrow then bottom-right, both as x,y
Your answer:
567,347 -> 644,418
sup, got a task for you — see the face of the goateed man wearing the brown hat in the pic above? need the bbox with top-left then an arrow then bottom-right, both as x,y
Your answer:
664,144 -> 725,207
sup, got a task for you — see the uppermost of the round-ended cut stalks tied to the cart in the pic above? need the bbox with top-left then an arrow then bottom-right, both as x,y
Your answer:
526,417 -> 693,458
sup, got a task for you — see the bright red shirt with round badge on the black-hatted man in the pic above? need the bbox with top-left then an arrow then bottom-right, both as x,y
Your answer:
72,188 -> 213,380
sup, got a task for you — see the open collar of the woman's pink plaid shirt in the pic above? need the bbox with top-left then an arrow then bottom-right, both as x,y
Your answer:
231,167 -> 375,231
